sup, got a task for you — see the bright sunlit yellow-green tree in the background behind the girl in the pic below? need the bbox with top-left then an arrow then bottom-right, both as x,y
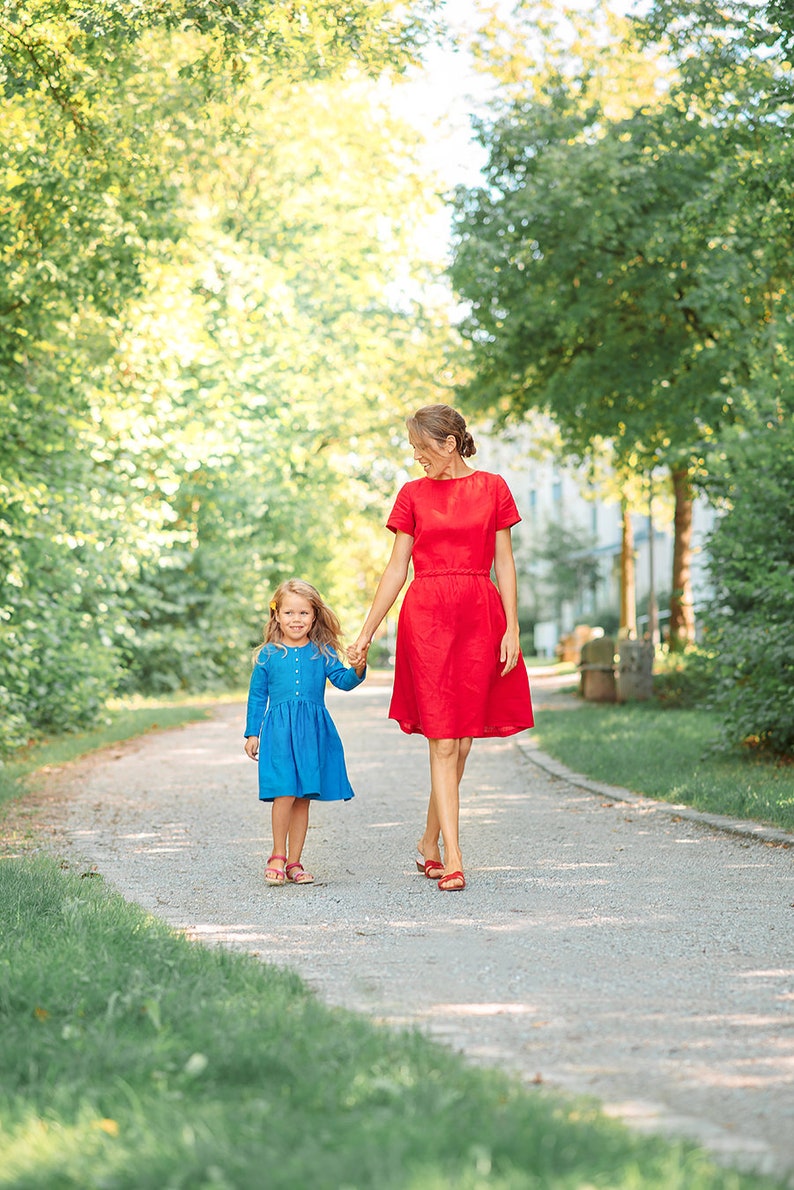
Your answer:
109,71 -> 459,685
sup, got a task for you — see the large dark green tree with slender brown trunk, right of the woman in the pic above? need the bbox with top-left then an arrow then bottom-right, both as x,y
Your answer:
451,0 -> 790,645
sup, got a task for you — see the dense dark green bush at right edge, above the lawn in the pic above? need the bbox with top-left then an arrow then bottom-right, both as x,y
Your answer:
708,409 -> 794,757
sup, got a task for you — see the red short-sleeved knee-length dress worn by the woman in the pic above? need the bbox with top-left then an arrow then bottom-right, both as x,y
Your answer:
387,471 -> 533,739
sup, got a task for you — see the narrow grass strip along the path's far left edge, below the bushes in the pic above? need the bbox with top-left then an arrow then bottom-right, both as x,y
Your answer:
0,695 -> 219,806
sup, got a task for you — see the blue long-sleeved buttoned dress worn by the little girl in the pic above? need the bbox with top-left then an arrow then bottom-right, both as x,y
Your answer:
245,641 -> 365,802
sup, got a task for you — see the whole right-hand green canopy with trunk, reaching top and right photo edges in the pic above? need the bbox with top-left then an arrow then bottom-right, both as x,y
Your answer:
451,0 -> 794,661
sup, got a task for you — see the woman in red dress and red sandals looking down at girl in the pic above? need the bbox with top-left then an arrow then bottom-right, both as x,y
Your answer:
349,405 -> 533,893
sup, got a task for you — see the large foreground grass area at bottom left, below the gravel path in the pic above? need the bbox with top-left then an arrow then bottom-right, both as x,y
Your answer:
0,858 -> 780,1190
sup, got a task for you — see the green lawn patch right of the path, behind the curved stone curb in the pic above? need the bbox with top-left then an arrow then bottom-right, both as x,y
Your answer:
533,702 -> 794,831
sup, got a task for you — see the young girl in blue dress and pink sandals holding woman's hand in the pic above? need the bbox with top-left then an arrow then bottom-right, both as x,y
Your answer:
245,578 -> 367,884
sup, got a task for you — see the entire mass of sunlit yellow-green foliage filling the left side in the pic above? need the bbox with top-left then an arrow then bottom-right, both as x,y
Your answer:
0,0 -> 457,753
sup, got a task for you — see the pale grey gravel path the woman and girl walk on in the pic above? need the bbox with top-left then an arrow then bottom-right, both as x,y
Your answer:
18,682 -> 794,1186
